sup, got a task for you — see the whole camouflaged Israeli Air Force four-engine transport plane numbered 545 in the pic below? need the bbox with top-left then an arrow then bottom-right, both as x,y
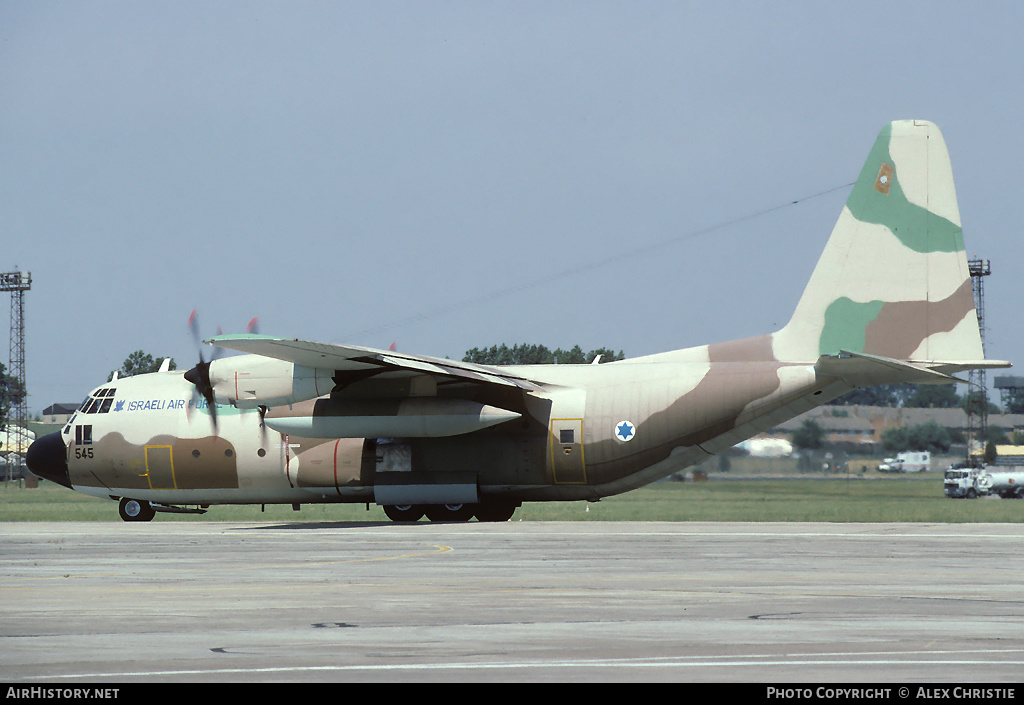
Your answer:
28,121 -> 1009,521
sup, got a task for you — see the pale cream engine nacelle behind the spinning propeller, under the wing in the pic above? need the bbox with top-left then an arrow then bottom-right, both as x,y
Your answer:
210,355 -> 334,409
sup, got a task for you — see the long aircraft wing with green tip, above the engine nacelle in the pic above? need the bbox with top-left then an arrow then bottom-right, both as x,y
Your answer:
205,334 -> 543,391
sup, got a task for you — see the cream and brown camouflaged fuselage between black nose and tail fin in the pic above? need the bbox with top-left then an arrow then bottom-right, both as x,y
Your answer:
29,341 -> 831,505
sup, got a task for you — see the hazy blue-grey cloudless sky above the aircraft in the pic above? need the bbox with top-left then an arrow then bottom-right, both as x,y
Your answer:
0,0 -> 1024,414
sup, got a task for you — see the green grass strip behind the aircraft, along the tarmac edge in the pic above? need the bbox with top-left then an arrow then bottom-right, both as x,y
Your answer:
0,473 -> 1024,523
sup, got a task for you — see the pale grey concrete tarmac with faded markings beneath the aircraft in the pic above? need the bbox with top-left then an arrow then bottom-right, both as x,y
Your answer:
0,520 -> 1024,687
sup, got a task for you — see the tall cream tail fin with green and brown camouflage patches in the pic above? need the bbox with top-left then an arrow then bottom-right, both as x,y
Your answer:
773,120 -> 1006,373
